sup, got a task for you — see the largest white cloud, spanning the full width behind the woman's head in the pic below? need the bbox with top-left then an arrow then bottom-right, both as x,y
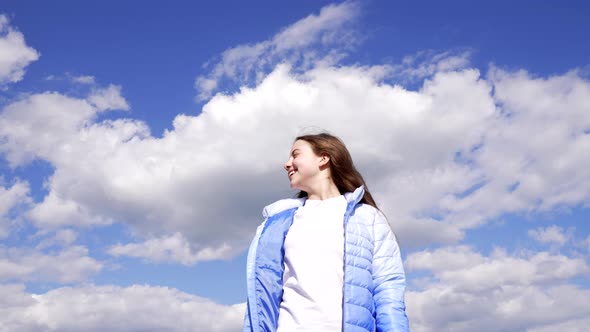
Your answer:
0,60 -> 590,263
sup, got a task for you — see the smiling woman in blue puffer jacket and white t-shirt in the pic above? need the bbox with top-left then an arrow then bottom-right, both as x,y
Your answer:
244,134 -> 409,332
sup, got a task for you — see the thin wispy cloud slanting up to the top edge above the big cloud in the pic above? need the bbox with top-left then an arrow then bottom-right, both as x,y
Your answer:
195,1 -> 360,100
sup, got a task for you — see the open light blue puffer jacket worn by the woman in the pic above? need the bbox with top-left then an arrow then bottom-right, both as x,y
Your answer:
244,187 -> 409,332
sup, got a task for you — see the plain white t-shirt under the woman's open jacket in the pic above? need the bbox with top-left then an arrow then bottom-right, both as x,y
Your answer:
277,195 -> 347,332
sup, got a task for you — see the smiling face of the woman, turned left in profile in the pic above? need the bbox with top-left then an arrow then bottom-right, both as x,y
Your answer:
284,140 -> 323,192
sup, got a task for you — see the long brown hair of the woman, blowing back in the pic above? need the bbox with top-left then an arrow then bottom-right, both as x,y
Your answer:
295,133 -> 378,209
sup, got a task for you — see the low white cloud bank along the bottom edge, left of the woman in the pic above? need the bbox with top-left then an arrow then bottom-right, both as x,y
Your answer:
0,284 -> 245,332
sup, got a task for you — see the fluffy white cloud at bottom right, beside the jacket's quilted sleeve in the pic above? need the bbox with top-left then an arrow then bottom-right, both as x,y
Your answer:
406,246 -> 590,332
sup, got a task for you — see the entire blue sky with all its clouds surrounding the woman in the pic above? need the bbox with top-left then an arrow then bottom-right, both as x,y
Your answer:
0,0 -> 590,331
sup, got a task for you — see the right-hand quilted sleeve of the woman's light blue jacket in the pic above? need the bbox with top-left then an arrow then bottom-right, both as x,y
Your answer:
373,211 -> 409,332
